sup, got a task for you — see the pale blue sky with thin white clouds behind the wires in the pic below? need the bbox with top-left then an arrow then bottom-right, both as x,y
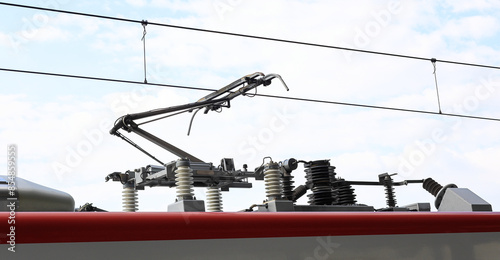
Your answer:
0,0 -> 500,211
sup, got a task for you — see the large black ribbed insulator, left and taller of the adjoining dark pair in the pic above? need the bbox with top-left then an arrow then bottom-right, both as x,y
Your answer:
304,160 -> 335,205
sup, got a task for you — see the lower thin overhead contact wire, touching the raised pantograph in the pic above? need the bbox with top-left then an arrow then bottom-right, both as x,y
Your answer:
0,67 -> 500,122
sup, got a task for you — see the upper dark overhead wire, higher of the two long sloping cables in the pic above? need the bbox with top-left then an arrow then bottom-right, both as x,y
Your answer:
0,2 -> 500,69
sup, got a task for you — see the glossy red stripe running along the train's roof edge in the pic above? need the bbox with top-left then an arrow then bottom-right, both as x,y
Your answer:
0,212 -> 500,244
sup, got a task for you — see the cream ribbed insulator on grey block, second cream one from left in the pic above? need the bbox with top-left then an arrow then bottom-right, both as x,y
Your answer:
175,159 -> 194,200
